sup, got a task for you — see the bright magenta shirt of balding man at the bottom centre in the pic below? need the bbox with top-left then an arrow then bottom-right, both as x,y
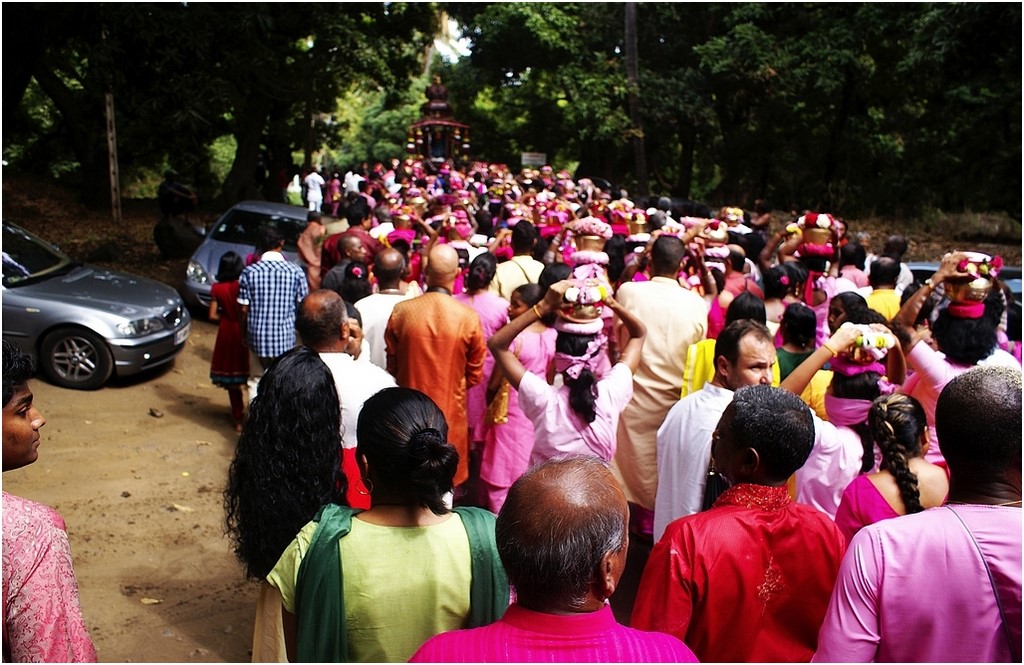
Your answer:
410,605 -> 697,663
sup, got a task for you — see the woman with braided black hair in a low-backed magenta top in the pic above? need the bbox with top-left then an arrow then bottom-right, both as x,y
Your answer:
836,392 -> 949,542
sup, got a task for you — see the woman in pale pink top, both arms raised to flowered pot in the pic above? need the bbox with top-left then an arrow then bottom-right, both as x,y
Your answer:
487,280 -> 647,465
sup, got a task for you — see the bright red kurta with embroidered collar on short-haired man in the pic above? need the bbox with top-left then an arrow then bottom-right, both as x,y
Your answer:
631,485 -> 846,663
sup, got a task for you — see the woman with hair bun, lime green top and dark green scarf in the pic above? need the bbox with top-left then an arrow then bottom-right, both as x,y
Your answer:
267,388 -> 509,663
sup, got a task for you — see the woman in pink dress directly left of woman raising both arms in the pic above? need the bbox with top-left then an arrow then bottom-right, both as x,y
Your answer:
480,284 -> 556,513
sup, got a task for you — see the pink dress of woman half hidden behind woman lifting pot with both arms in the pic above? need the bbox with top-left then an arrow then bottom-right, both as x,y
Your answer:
480,328 -> 558,513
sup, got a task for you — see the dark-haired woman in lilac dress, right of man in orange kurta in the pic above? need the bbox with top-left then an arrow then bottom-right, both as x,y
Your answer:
454,252 -> 509,443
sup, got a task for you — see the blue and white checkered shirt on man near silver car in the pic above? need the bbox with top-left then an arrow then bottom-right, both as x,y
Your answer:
239,253 -> 309,358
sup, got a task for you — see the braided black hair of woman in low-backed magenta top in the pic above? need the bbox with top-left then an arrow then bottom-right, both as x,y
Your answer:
867,392 -> 928,514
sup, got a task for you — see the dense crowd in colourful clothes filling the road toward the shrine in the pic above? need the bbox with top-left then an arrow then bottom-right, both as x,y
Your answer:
4,154 -> 1022,662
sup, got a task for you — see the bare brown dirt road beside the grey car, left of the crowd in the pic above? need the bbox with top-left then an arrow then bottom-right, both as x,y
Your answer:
3,321 -> 256,662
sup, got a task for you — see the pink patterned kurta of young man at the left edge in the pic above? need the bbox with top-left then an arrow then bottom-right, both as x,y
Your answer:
3,492 -> 96,663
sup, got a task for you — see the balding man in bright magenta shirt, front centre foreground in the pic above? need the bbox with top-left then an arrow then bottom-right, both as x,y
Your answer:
411,457 -> 696,663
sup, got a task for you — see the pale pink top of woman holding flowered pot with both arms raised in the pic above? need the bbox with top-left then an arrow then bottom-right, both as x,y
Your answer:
519,363 -> 633,466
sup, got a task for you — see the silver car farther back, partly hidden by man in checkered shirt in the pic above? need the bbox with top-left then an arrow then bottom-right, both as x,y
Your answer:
184,201 -> 306,310
